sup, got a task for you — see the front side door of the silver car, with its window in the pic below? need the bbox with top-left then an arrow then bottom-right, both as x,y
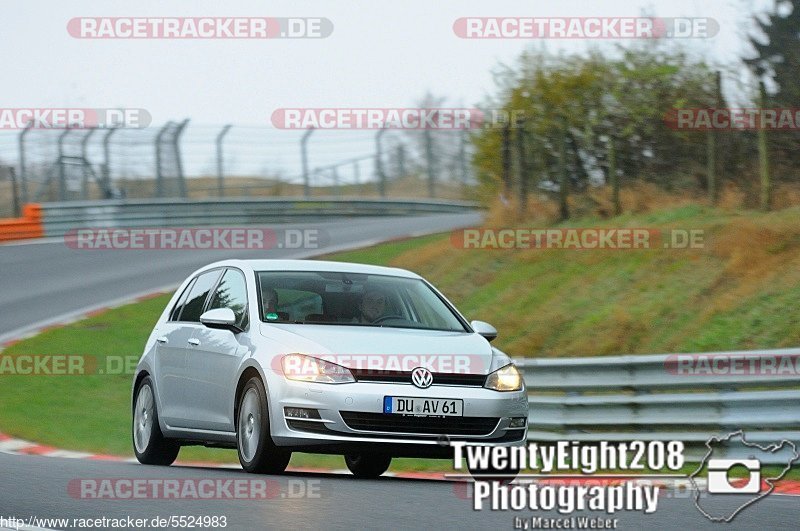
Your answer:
186,268 -> 250,431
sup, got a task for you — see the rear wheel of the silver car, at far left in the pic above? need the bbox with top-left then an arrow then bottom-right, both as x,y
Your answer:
131,376 -> 181,466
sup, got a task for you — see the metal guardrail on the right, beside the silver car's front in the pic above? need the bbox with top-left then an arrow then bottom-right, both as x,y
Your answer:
515,348 -> 800,464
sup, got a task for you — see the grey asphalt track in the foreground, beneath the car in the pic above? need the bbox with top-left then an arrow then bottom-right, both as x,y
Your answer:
0,454 -> 800,530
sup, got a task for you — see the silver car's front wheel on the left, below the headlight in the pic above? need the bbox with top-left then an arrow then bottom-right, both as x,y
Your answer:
236,377 -> 292,474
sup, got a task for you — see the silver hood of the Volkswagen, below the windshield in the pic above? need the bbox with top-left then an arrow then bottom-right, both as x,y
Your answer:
260,323 -> 507,374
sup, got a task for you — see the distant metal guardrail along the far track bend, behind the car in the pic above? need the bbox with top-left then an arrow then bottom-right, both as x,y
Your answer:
41,197 -> 479,236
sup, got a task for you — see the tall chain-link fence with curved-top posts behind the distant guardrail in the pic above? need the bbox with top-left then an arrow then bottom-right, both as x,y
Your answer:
0,120 -> 474,216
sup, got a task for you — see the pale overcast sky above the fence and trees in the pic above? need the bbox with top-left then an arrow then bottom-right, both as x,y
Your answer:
0,0 -> 770,125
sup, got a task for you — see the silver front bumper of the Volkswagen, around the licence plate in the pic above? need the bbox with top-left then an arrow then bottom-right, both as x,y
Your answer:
270,380 -> 528,457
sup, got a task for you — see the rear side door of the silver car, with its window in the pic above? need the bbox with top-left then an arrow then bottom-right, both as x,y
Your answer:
156,269 -> 222,428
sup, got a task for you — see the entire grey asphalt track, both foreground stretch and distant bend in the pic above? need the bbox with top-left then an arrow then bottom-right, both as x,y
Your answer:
0,214 -> 800,529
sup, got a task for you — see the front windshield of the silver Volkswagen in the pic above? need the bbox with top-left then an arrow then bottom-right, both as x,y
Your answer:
256,271 -> 468,332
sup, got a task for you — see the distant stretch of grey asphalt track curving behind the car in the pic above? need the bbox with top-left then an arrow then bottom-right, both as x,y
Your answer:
0,213 -> 480,343
